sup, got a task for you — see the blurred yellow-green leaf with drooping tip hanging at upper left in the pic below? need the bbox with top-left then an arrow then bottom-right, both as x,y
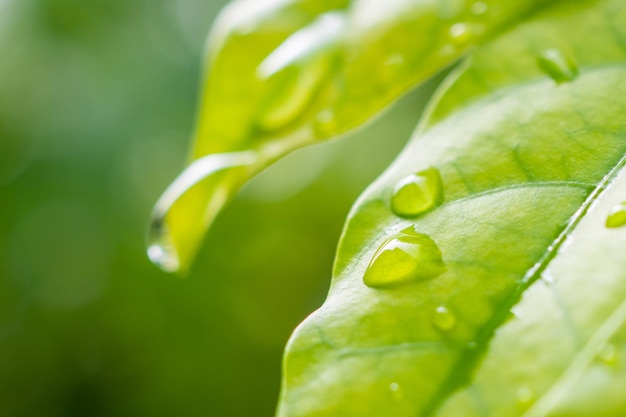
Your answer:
149,0 -> 549,271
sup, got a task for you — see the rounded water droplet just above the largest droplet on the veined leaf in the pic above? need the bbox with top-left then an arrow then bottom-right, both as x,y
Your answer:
391,168 -> 443,218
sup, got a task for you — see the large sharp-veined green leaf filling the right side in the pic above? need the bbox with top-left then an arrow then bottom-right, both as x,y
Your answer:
278,0 -> 626,417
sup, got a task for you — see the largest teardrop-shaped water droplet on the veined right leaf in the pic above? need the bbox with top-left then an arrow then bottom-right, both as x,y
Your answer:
363,226 -> 446,288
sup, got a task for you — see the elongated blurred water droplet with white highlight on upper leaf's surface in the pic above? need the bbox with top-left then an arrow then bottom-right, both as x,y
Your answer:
257,13 -> 345,131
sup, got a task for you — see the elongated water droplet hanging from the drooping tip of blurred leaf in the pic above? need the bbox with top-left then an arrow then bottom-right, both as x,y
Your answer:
148,151 -> 258,272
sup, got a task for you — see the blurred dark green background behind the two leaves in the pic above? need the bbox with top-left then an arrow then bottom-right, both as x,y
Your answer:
0,0 -> 425,417
